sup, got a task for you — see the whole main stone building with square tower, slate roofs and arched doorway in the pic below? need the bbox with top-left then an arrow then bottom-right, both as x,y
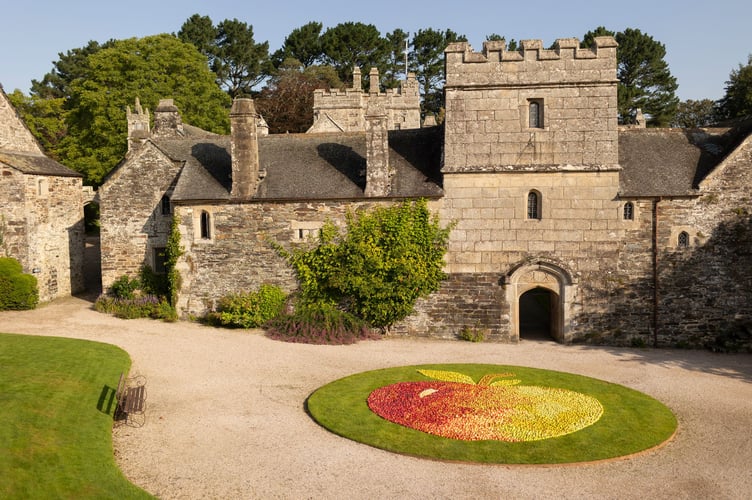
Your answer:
100,37 -> 752,346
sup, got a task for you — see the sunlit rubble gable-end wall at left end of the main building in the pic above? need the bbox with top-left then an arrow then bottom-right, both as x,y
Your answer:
99,143 -> 179,291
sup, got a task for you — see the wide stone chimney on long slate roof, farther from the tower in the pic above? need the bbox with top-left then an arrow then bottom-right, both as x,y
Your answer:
230,98 -> 259,199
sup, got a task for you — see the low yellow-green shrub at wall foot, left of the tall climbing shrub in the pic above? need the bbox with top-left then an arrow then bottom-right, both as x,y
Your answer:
207,284 -> 287,328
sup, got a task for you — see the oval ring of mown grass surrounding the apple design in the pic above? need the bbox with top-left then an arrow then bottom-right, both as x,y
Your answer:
307,364 -> 677,464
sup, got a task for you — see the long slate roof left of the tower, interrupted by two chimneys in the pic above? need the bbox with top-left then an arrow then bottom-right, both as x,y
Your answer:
167,127 -> 443,201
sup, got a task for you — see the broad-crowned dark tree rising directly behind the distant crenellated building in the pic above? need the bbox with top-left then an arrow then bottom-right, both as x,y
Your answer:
321,22 -> 388,84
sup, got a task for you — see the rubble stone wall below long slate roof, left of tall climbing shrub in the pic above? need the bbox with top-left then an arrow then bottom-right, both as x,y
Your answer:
176,197 -> 412,316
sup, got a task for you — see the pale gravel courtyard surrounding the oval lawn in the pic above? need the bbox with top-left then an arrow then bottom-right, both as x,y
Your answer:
0,298 -> 752,499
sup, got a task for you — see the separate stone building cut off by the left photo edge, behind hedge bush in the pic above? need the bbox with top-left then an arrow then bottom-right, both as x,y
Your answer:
0,87 -> 85,301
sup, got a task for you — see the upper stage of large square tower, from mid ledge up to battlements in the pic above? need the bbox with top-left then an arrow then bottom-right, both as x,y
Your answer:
444,37 -> 618,173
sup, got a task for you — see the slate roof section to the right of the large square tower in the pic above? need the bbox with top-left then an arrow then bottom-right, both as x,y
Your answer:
619,128 -> 735,197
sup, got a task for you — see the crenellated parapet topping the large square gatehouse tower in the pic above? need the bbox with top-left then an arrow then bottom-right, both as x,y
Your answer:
444,36 -> 617,88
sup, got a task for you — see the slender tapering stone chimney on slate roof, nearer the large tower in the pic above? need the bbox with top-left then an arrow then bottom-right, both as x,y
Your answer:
365,102 -> 392,197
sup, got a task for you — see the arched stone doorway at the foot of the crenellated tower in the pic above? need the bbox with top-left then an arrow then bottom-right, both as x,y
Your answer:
505,261 -> 576,343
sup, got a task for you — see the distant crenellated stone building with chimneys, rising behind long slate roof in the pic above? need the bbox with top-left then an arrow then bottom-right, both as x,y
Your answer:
308,67 -> 420,134
